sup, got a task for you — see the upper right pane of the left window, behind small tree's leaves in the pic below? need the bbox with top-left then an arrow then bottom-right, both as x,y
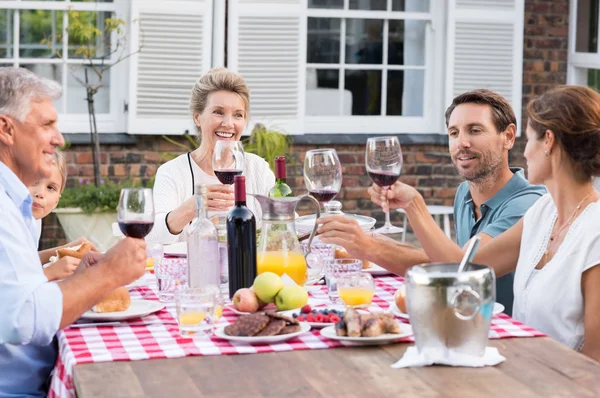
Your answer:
68,11 -> 112,59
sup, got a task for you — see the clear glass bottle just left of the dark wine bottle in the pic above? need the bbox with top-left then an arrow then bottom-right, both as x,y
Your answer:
186,184 -> 221,287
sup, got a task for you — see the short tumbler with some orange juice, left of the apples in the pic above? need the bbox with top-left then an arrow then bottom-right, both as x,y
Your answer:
175,287 -> 218,337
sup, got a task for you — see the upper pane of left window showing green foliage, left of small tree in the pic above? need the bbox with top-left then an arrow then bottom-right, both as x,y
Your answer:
19,10 -> 63,58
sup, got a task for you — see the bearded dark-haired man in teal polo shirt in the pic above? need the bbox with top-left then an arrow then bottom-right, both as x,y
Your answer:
320,90 -> 546,314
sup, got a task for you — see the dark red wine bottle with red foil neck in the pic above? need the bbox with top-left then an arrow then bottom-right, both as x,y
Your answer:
227,176 -> 256,298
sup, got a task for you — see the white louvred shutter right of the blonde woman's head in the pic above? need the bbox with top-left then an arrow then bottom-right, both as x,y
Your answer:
227,0 -> 306,134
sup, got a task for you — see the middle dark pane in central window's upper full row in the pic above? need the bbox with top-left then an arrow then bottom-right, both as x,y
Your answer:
346,19 -> 383,64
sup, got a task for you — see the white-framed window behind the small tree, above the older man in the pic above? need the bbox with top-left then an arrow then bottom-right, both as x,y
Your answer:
0,0 -> 124,132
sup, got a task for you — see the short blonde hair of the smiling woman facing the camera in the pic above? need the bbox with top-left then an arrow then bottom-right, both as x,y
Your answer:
190,68 -> 250,140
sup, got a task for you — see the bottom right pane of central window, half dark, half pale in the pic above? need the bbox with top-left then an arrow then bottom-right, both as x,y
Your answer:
386,70 -> 425,116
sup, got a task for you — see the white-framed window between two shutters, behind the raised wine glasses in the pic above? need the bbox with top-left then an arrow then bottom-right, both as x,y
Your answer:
305,0 -> 443,132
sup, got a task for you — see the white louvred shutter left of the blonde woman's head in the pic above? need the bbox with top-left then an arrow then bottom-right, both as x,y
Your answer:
128,0 -> 212,134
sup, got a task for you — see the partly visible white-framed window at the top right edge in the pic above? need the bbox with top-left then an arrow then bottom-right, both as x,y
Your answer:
567,0 -> 600,90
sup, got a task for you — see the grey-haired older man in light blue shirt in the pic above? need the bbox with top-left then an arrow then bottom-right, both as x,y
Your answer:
0,68 -> 147,397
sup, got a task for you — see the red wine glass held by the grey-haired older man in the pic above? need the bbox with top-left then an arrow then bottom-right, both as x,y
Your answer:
117,188 -> 154,239
